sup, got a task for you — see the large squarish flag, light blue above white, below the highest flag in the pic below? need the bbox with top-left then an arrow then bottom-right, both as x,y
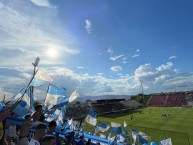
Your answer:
45,84 -> 68,108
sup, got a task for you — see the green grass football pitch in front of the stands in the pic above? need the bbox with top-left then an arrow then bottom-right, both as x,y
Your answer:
85,107 -> 193,145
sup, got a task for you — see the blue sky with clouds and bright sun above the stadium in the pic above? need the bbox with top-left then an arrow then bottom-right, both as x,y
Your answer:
0,0 -> 193,98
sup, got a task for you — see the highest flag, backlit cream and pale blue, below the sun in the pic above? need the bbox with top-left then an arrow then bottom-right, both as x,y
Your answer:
30,70 -> 53,87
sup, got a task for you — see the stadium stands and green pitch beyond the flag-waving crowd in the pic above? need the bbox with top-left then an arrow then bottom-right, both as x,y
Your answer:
66,91 -> 193,145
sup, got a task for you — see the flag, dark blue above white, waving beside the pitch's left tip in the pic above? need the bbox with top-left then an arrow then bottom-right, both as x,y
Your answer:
85,109 -> 97,126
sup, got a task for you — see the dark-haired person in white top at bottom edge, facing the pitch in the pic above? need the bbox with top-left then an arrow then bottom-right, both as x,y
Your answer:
28,124 -> 46,145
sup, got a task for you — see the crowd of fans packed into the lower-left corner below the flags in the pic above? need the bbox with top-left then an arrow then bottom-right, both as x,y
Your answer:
0,105 -> 91,145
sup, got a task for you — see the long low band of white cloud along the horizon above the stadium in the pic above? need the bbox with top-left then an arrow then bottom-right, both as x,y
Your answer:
0,63 -> 193,97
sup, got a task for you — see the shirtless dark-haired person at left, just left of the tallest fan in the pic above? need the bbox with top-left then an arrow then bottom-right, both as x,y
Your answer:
18,115 -> 32,145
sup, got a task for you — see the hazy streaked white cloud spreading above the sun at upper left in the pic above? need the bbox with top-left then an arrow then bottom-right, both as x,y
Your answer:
0,1 -> 79,65
